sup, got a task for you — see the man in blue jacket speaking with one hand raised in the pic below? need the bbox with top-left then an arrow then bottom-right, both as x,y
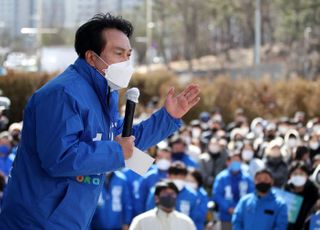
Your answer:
0,14 -> 199,230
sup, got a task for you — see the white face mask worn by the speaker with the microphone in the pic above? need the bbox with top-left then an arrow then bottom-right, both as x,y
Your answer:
96,54 -> 134,90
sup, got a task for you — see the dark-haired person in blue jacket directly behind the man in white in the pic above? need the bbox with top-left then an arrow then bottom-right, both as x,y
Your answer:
146,161 -> 198,227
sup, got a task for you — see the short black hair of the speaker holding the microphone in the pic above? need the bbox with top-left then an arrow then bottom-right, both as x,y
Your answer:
74,13 -> 133,58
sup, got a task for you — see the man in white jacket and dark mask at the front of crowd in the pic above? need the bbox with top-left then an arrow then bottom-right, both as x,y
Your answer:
129,180 -> 196,230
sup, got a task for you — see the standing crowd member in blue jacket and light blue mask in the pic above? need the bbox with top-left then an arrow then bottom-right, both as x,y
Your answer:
212,151 -> 254,230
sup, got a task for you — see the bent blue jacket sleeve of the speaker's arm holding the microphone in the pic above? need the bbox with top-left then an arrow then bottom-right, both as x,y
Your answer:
34,90 -> 124,177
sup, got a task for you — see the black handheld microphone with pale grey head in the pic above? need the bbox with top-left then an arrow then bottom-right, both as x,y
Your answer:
122,88 -> 140,137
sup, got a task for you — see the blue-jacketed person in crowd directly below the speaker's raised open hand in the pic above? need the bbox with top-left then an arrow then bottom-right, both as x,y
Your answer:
169,135 -> 199,168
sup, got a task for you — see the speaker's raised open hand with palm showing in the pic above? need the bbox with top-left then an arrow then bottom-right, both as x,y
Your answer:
164,84 -> 200,118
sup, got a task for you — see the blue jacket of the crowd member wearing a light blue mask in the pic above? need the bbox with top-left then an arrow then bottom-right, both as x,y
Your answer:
212,169 -> 254,222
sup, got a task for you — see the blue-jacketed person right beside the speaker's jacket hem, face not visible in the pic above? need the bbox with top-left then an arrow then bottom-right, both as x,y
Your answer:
91,171 -> 133,230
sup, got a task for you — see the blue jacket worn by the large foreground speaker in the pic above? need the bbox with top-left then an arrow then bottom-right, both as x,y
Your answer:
0,58 -> 181,229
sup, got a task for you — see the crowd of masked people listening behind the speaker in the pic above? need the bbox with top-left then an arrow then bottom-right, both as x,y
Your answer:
0,109 -> 320,230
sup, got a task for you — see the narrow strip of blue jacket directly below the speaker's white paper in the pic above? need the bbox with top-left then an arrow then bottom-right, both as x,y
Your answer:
122,168 -> 142,217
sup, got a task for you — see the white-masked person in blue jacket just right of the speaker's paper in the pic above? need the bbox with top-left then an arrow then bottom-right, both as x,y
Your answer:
138,148 -> 171,214
